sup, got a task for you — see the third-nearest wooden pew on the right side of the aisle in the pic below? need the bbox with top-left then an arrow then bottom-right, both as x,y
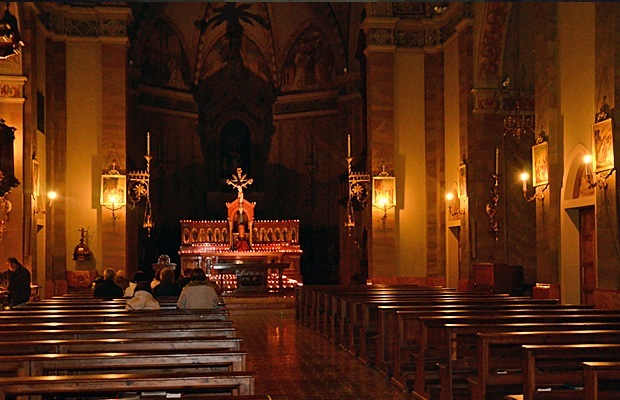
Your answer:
464,330 -> 620,399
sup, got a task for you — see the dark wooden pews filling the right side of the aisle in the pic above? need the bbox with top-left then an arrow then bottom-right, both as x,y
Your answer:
296,285 -> 620,400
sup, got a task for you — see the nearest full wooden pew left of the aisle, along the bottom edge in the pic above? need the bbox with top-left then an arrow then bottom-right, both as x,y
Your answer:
0,372 -> 255,400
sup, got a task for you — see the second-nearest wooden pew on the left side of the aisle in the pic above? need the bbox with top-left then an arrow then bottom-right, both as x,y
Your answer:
0,350 -> 246,376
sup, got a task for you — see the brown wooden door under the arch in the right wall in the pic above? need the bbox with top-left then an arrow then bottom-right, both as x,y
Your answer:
579,207 -> 596,305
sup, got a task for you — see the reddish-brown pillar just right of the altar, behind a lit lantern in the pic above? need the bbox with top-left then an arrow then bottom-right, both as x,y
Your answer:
364,17 -> 398,277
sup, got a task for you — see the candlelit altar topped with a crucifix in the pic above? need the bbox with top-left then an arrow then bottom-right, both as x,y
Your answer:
179,169 -> 302,290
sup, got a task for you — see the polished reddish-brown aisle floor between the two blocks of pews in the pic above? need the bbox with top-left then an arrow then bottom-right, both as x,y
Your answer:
228,298 -> 411,400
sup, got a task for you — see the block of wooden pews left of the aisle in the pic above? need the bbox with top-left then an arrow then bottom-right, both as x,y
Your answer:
0,296 -> 269,400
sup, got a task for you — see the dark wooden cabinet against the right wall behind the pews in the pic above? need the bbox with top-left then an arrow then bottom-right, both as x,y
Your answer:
473,263 -> 523,296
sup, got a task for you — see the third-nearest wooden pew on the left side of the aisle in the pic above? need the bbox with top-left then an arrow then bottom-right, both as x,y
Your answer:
0,337 -> 241,355
